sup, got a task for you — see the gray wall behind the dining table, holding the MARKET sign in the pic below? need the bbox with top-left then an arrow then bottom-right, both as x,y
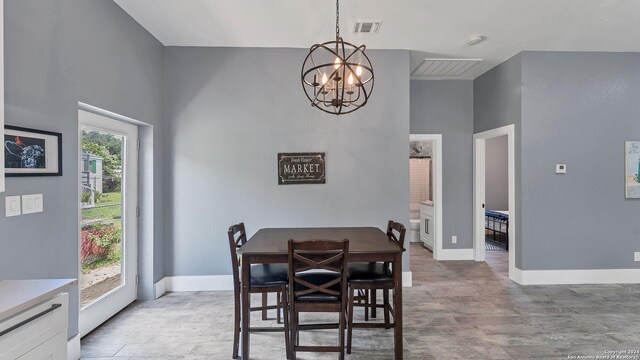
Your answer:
164,47 -> 409,276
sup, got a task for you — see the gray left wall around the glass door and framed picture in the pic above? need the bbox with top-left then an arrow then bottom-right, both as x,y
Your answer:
0,0 -> 163,336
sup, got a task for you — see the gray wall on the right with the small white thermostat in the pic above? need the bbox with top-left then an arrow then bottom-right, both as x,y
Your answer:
522,52 -> 640,270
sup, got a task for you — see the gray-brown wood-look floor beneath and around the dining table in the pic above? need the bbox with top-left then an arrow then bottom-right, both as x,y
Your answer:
82,244 -> 640,360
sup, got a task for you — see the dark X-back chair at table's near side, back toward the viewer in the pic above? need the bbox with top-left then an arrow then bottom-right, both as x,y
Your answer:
288,239 -> 349,360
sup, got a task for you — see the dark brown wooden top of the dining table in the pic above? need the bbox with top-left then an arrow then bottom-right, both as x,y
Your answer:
238,227 -> 404,255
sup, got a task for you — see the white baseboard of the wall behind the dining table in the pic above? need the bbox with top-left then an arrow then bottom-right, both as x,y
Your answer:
162,271 -> 413,292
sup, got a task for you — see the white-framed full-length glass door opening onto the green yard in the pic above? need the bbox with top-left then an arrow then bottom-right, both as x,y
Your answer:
78,110 -> 138,336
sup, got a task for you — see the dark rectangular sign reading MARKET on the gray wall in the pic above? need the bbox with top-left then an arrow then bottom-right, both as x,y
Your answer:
278,153 -> 326,185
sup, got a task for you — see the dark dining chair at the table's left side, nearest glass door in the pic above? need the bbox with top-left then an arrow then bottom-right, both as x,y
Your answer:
227,223 -> 289,359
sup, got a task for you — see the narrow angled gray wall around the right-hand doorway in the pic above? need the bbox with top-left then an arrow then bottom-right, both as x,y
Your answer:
473,54 -> 524,269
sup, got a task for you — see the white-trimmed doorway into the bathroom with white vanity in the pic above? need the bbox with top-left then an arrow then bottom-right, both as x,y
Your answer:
409,134 -> 443,260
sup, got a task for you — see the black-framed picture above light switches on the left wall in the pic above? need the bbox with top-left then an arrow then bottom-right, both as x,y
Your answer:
3,125 -> 62,177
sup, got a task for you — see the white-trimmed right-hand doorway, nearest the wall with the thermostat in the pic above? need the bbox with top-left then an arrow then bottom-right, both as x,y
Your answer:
473,125 -> 517,280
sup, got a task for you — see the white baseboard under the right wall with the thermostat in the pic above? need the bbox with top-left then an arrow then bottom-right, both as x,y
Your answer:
512,269 -> 640,285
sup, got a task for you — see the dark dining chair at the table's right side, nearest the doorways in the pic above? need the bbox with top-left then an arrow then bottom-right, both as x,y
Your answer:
347,220 -> 406,354
